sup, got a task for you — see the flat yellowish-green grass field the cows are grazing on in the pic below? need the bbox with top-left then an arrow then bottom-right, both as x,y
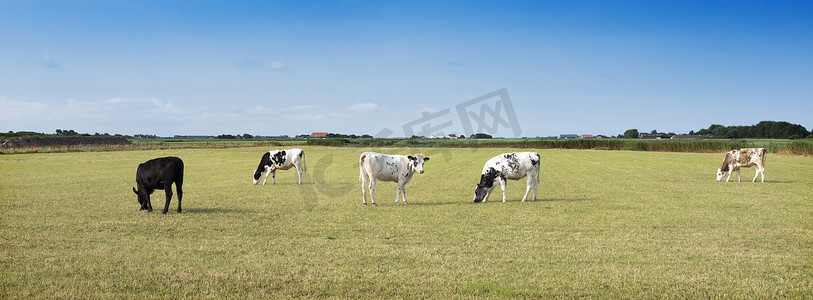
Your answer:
0,146 -> 813,299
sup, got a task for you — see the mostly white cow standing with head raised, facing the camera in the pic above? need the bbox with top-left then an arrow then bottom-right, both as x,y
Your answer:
359,152 -> 429,205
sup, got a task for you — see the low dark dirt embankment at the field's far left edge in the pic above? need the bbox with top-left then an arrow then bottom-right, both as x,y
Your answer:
0,136 -> 131,149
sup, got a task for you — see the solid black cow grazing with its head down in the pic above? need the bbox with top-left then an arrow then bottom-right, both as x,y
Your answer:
133,156 -> 183,214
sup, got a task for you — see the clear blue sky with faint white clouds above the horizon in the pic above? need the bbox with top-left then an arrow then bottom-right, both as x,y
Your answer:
0,0 -> 813,136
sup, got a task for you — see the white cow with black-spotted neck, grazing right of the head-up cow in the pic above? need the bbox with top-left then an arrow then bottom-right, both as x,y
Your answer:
474,152 -> 539,202
